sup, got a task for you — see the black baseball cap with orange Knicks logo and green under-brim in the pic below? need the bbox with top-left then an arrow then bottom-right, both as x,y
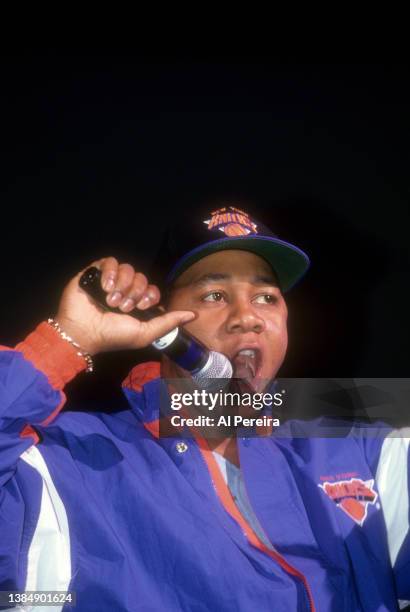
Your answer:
155,205 -> 310,291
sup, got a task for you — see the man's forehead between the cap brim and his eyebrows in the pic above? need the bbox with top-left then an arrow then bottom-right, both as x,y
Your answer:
174,249 -> 277,287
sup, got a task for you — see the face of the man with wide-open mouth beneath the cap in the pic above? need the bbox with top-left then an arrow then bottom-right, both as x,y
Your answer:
168,250 -> 287,391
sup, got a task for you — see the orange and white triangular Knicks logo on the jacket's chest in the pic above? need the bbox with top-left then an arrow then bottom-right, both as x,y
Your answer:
318,478 -> 377,526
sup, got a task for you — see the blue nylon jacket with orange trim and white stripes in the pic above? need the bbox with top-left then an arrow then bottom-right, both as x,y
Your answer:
0,330 -> 410,612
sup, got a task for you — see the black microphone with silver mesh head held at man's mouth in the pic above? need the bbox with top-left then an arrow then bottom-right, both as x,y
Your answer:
79,266 -> 232,390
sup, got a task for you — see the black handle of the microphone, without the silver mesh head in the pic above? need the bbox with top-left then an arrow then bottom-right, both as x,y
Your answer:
79,266 -> 209,373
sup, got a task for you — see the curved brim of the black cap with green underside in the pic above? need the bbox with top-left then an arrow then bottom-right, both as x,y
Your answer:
166,235 -> 310,291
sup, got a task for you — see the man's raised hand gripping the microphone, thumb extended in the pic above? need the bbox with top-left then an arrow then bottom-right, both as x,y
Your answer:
56,257 -> 195,355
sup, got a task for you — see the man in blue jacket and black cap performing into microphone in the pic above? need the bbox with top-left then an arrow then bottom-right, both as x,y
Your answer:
0,206 -> 410,612
